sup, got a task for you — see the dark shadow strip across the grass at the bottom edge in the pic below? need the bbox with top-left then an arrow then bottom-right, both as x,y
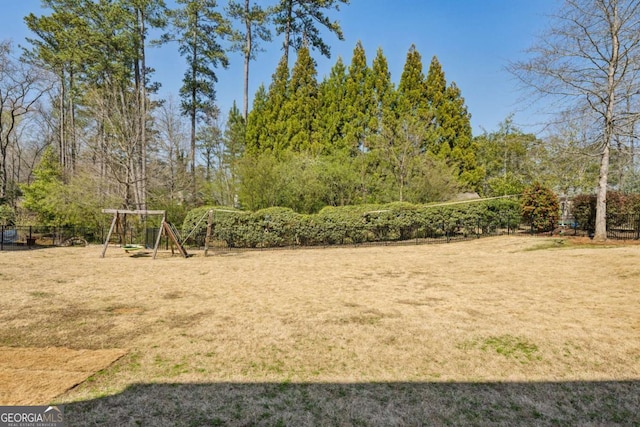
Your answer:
65,381 -> 640,426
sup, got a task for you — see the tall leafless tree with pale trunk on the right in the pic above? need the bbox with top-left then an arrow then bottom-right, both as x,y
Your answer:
510,0 -> 640,240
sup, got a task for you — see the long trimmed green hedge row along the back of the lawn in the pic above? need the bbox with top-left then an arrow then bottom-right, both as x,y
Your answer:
182,199 -> 520,248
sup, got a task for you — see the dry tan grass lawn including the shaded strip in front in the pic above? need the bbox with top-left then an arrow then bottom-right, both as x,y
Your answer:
0,237 -> 640,425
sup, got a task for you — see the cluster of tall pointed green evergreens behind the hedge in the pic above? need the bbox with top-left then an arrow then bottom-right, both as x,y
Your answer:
245,42 -> 482,209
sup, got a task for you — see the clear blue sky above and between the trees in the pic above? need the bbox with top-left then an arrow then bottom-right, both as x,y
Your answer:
0,0 -> 560,134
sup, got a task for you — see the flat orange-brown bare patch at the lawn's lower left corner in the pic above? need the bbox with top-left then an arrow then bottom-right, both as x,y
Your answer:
0,347 -> 126,405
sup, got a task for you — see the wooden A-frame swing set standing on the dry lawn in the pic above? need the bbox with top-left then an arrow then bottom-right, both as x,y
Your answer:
100,209 -> 189,259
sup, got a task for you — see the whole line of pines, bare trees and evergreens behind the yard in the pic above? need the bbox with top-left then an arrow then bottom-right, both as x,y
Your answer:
0,0 -> 640,234
